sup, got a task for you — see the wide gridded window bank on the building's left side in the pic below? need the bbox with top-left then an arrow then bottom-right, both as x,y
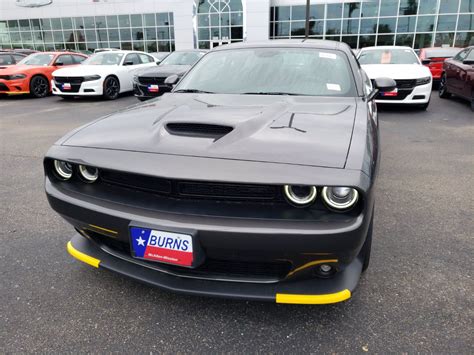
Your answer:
0,12 -> 175,53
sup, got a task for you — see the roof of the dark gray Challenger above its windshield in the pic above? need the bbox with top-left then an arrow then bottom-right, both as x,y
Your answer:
211,39 -> 352,55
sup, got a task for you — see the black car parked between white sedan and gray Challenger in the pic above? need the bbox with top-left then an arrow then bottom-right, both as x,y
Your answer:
133,50 -> 206,101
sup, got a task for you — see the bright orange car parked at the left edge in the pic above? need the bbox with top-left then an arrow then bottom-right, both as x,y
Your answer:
0,52 -> 87,98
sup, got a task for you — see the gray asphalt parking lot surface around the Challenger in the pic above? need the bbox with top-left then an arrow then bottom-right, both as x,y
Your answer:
0,92 -> 474,354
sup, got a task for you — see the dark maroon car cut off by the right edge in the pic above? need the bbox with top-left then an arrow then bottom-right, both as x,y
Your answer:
439,46 -> 474,111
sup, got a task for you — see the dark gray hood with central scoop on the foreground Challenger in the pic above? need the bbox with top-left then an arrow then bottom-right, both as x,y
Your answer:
59,94 -> 357,168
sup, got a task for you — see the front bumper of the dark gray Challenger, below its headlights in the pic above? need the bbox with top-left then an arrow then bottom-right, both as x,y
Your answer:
46,172 -> 373,303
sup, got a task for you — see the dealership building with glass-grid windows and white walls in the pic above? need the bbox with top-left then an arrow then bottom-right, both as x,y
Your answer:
0,0 -> 474,52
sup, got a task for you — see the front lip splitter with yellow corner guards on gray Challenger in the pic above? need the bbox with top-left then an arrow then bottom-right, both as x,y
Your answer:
67,234 -> 362,304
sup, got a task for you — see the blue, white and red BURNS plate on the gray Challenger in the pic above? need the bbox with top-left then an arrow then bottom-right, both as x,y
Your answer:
130,227 -> 194,266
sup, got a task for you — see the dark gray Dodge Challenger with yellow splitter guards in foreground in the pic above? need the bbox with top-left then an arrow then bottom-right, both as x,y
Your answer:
44,40 -> 395,304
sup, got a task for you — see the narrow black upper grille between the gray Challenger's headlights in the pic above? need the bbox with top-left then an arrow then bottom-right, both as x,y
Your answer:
100,170 -> 282,201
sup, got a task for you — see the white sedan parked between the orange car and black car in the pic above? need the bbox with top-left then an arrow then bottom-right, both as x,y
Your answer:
51,50 -> 156,100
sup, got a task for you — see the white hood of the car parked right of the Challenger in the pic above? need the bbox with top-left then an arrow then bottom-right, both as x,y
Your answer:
362,64 -> 431,79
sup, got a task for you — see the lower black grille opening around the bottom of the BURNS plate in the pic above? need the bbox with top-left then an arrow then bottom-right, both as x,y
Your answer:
85,230 -> 292,282
